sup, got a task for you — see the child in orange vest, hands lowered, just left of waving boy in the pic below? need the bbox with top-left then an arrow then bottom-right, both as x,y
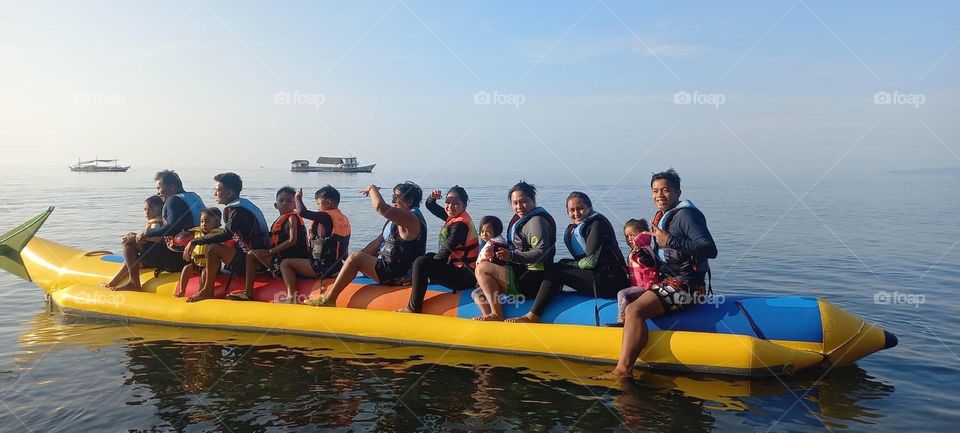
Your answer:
227,186 -> 310,301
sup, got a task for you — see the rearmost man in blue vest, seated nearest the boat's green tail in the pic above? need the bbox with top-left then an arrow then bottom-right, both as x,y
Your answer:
106,170 -> 204,290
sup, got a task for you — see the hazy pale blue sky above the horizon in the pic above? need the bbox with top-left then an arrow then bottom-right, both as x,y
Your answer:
0,0 -> 960,179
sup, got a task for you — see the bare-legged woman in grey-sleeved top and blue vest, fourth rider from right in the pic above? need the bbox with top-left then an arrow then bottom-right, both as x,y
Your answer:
476,181 -> 557,320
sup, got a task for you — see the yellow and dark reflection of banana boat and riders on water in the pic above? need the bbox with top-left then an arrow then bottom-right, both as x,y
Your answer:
18,313 -> 894,431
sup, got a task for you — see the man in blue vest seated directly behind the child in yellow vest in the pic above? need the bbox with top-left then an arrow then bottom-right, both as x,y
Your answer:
186,173 -> 270,302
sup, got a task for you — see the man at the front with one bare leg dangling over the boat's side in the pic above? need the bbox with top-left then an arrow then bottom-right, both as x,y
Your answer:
610,168 -> 717,377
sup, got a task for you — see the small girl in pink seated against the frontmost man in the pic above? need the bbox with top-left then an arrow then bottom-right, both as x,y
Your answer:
617,219 -> 660,323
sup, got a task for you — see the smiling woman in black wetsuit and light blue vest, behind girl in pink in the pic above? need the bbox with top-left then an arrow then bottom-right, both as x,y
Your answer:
507,191 -> 630,322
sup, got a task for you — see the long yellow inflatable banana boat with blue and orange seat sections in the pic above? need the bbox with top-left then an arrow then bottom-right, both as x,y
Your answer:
0,208 -> 897,377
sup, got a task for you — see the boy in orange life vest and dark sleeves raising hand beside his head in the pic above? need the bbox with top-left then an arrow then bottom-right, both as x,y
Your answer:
280,185 -> 351,303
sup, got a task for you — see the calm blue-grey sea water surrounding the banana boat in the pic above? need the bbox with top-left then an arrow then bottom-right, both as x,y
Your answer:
0,168 -> 960,432
